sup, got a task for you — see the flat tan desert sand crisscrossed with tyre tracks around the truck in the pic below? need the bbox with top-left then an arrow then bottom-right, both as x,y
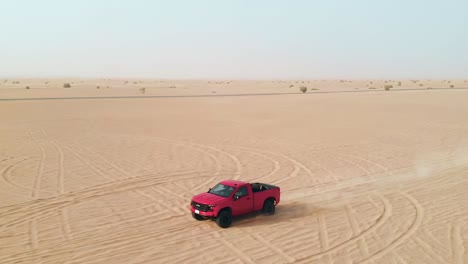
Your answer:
0,80 -> 468,264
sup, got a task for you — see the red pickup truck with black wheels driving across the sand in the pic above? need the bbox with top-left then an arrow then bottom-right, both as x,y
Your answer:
190,180 -> 280,228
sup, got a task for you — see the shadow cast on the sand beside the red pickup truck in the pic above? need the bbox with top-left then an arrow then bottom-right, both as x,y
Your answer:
226,202 -> 333,228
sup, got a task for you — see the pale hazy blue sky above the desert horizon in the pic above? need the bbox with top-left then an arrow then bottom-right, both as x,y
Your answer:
0,0 -> 468,79
